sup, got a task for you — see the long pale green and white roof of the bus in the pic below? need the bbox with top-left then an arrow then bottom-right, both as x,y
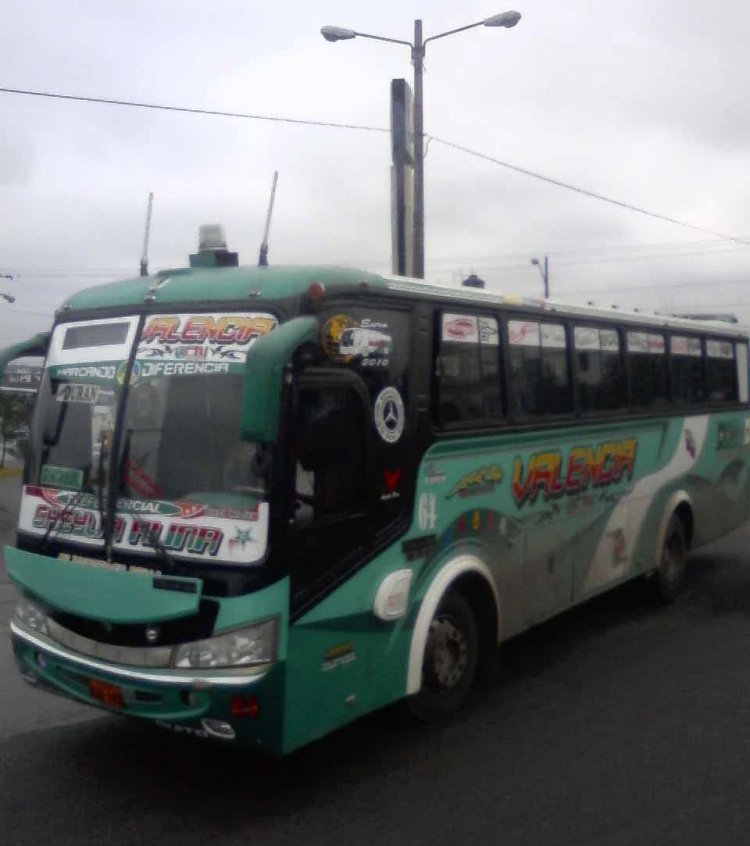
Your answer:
61,265 -> 747,337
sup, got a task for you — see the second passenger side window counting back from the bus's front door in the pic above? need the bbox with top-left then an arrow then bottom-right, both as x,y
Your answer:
508,320 -> 572,416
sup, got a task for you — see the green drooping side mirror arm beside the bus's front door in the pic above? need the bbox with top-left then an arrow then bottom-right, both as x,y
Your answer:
240,316 -> 319,444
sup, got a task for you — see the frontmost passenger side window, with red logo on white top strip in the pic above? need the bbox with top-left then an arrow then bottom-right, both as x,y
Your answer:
437,313 -> 503,426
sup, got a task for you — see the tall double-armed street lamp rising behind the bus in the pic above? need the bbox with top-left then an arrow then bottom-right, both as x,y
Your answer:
320,11 -> 521,279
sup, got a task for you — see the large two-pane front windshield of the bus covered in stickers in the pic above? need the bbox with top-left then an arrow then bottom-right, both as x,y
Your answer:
19,314 -> 275,565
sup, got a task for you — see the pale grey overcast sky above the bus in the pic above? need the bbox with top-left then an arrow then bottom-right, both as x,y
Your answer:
0,0 -> 750,343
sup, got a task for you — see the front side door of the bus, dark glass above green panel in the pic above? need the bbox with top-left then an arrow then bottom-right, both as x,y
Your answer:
285,368 -> 372,743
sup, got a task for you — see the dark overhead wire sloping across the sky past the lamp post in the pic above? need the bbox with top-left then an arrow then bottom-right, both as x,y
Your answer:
0,87 -> 750,246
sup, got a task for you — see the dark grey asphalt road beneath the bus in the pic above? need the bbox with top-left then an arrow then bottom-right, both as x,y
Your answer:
0,481 -> 750,846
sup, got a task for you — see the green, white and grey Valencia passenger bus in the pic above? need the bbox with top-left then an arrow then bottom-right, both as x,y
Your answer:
2,243 -> 750,755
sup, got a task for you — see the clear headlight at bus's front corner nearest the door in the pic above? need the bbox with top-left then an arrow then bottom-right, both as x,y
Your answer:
172,619 -> 277,669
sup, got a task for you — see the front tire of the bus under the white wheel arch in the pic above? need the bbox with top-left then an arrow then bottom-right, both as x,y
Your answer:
406,590 -> 479,723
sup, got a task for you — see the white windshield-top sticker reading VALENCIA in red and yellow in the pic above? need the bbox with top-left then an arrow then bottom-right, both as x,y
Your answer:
137,313 -> 278,364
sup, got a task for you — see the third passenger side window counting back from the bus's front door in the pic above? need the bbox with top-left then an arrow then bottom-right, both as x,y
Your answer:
574,326 -> 627,411
